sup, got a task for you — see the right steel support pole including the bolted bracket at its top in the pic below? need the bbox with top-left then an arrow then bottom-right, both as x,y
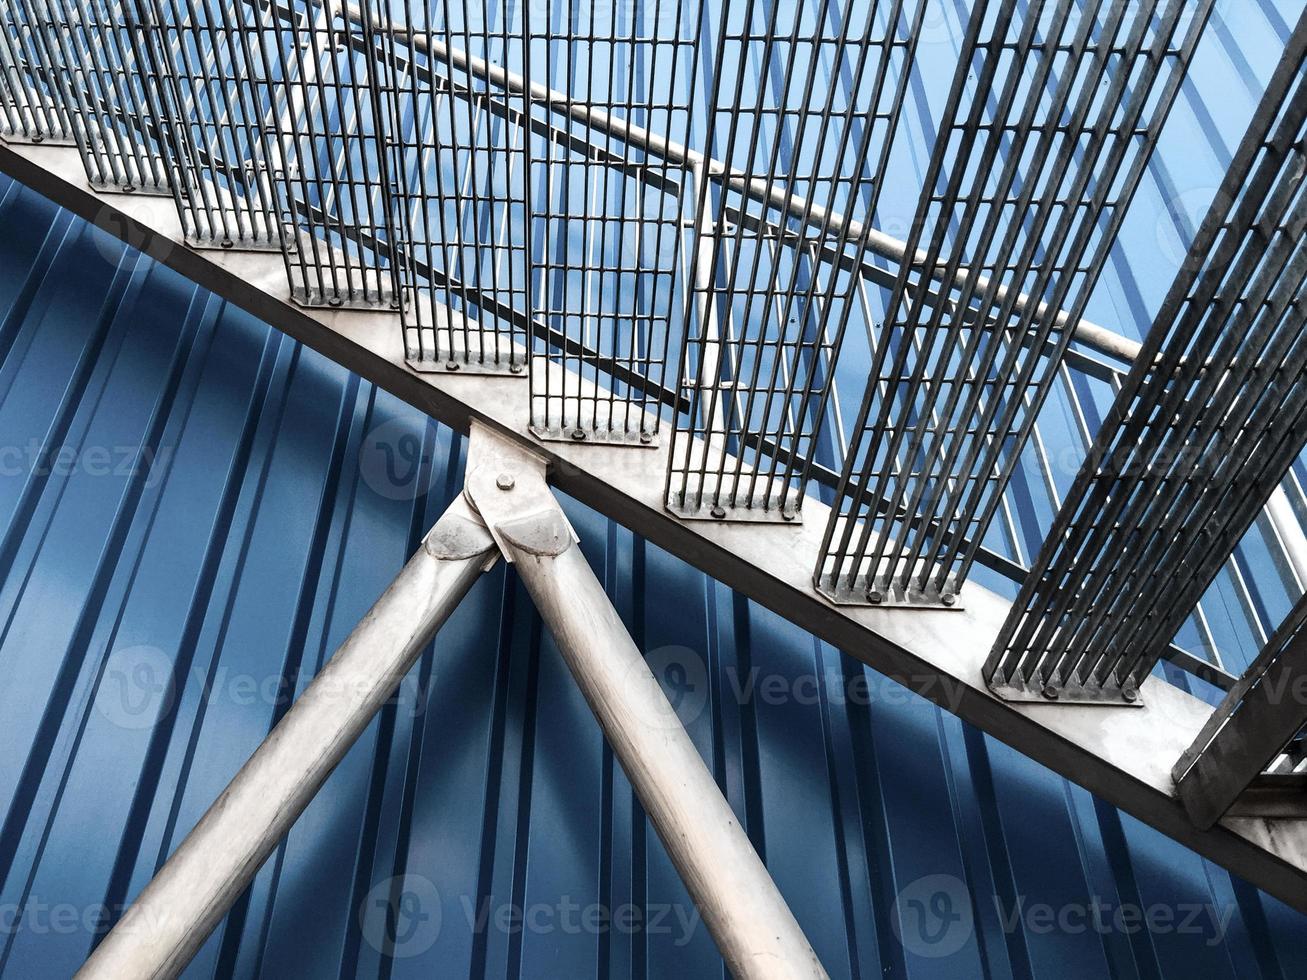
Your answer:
465,423 -> 826,980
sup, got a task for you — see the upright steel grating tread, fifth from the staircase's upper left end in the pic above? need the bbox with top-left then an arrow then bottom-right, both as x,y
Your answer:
380,0 -> 531,372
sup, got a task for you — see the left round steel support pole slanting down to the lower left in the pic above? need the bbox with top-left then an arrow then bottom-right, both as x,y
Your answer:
77,498 -> 499,980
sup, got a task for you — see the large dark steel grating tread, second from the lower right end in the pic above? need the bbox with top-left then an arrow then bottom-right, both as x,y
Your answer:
985,7 -> 1307,702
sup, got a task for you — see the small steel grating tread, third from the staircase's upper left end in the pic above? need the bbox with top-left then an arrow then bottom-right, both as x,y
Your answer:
133,0 -> 283,250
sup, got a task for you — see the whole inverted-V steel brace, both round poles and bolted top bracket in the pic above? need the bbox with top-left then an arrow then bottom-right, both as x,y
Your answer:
77,426 -> 826,980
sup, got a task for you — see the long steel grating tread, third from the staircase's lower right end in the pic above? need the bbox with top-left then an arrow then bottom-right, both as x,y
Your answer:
816,0 -> 1212,605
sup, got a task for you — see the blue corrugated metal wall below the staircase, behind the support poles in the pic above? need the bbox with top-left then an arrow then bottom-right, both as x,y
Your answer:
0,182 -> 1307,980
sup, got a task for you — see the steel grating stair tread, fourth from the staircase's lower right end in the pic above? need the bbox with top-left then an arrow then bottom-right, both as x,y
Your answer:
668,0 -> 925,520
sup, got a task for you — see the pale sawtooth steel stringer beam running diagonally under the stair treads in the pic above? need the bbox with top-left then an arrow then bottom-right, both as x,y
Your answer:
0,138 -> 1307,912
